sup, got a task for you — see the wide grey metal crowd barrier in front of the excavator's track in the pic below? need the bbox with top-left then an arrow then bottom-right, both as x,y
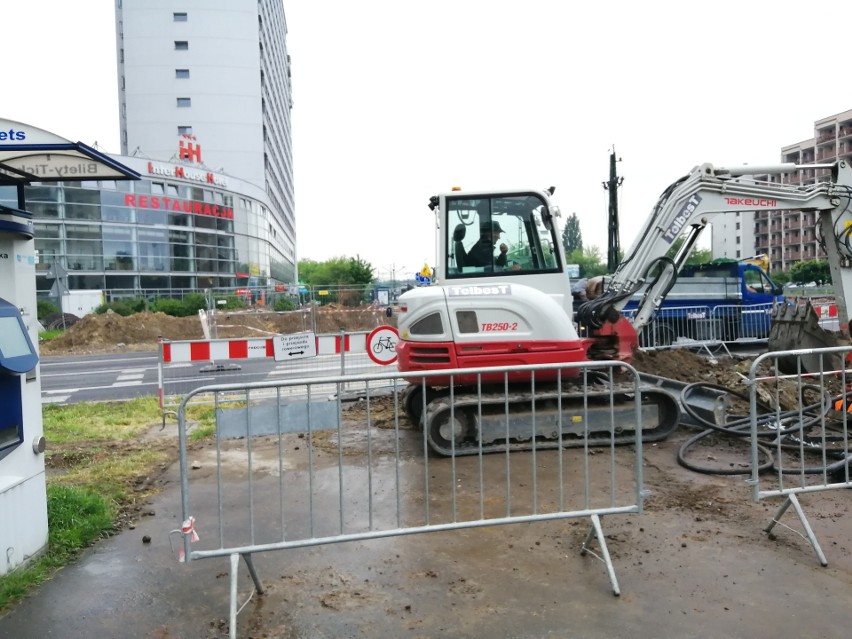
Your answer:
173,362 -> 647,637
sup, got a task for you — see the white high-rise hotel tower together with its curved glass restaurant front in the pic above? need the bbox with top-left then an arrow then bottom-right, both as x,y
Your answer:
0,0 -> 297,299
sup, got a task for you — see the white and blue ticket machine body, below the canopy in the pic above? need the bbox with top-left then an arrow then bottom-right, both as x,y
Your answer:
0,206 -> 47,575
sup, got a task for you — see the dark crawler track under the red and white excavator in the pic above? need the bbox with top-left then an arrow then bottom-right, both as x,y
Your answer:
421,383 -> 681,456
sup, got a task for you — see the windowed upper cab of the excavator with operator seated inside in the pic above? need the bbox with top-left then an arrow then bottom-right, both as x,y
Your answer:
442,193 -> 562,279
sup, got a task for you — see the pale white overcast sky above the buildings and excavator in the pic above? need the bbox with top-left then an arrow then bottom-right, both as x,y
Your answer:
6,0 -> 852,278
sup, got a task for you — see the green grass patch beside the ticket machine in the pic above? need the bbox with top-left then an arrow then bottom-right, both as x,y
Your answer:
0,397 -> 216,616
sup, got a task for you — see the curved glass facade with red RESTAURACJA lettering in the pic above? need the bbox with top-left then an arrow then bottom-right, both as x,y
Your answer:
0,161 -> 296,301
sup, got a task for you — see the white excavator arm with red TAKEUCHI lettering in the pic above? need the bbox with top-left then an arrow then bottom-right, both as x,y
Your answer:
577,161 -> 852,332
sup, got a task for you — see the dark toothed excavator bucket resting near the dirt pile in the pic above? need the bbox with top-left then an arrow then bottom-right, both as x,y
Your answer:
767,298 -> 843,375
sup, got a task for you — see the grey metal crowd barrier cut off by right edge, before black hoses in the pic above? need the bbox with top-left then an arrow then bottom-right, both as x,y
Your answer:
740,347 -> 852,566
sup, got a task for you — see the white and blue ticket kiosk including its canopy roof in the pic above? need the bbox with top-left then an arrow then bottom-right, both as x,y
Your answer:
0,119 -> 140,576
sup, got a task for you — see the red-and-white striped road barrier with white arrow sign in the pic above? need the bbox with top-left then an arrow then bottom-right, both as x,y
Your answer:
158,331 -> 383,412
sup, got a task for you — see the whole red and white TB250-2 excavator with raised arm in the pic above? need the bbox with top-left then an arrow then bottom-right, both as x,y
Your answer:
396,161 -> 852,454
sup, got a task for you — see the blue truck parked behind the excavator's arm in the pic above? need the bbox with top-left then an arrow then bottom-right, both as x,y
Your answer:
622,260 -> 784,347
